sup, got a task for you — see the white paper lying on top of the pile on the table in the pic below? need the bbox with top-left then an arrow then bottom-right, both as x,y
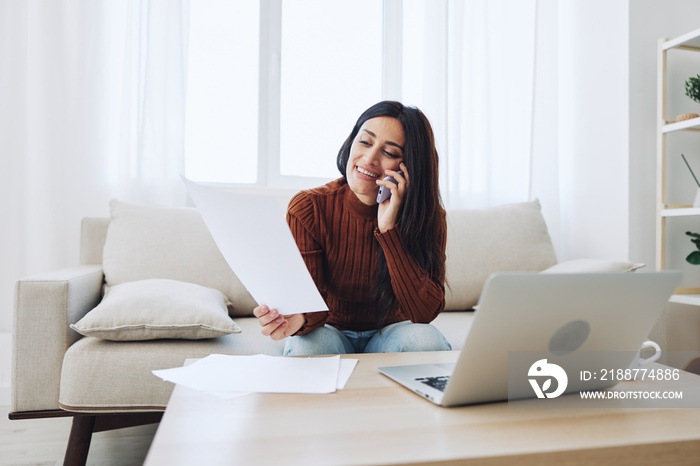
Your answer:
153,354 -> 340,394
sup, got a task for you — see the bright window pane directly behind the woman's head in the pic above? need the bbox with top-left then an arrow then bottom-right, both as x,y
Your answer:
280,0 -> 382,179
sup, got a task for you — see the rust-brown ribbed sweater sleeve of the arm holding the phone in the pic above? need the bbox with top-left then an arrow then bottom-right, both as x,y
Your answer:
375,217 -> 447,323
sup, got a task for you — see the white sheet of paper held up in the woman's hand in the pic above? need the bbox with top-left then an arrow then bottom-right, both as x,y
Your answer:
183,177 -> 328,314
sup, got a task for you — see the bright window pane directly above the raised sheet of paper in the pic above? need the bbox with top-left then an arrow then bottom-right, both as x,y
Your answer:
185,0 -> 260,183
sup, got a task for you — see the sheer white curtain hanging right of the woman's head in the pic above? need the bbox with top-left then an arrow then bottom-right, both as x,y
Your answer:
402,0 -> 562,246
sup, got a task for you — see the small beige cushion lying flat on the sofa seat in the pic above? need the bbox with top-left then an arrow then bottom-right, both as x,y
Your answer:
71,279 -> 241,341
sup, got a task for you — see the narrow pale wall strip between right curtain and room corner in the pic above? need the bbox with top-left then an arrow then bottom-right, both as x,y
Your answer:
558,0 -> 629,260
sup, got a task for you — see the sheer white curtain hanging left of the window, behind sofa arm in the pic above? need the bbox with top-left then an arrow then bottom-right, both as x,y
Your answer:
0,0 -> 188,331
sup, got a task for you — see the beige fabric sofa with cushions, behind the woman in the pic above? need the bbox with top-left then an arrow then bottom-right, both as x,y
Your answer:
10,201 -> 556,464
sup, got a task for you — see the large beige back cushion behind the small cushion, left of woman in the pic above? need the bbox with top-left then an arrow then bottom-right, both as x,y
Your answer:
103,200 -> 256,316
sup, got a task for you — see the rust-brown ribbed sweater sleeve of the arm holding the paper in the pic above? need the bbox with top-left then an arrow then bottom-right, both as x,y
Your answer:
287,192 -> 328,335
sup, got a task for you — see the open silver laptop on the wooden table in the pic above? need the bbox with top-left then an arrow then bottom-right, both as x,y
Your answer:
379,271 -> 681,406
